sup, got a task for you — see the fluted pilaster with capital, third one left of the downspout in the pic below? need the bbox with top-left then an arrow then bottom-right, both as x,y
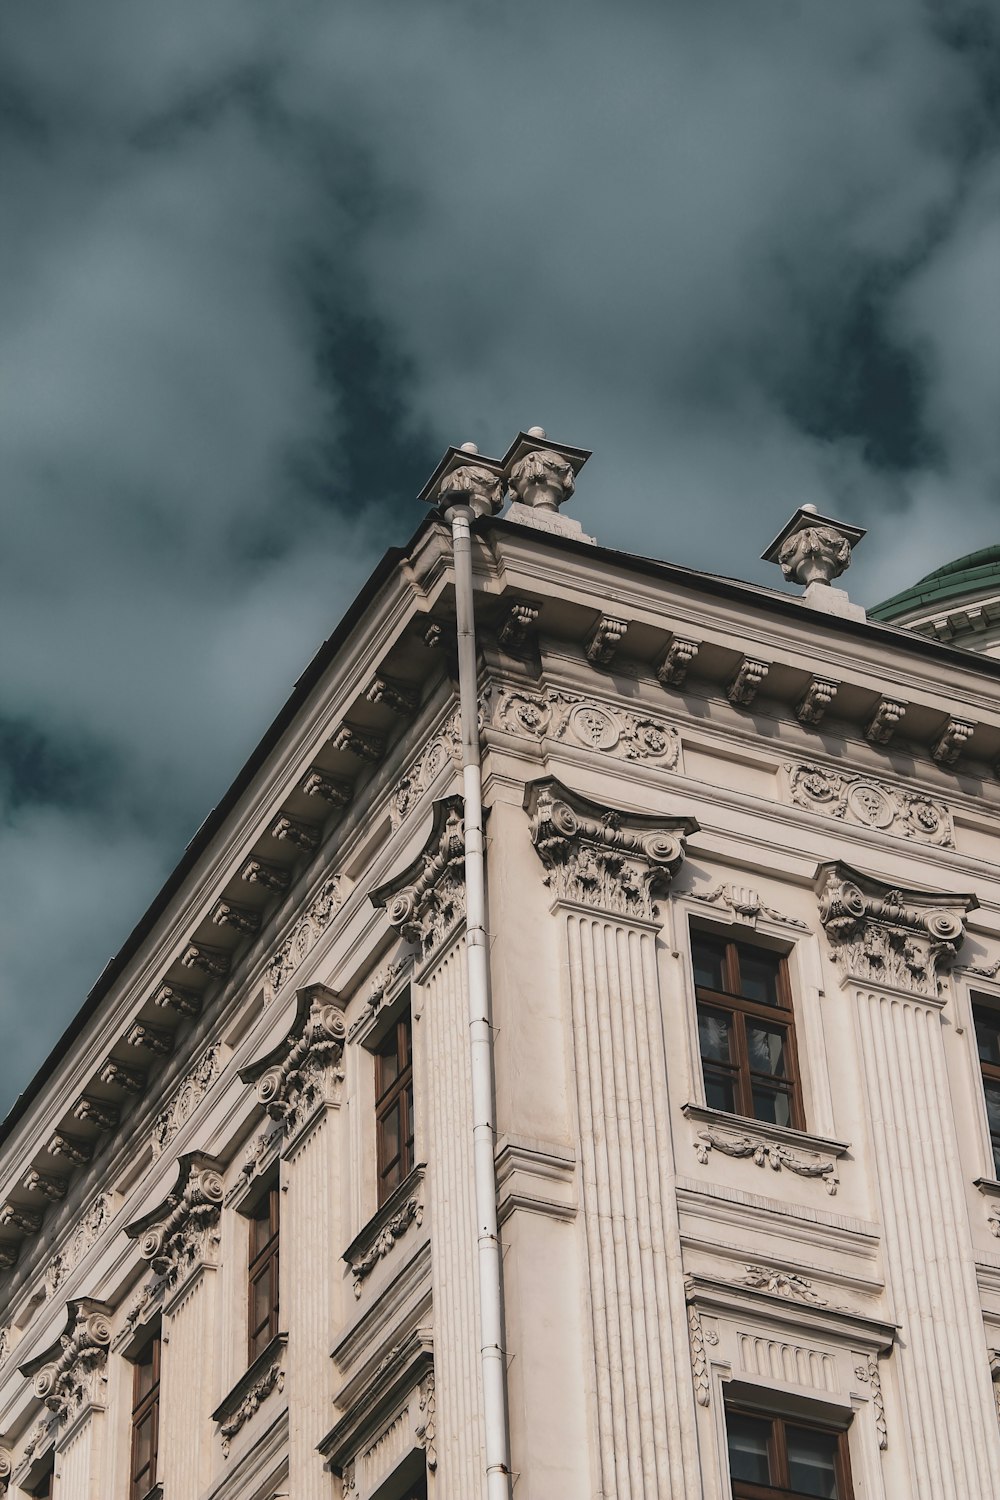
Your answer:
126,1154 -> 223,1496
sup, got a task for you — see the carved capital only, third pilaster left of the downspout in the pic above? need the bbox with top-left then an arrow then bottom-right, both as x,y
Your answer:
124,1152 -> 225,1289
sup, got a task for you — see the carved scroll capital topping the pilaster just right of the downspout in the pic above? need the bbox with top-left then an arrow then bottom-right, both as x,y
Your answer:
525,779 -> 697,923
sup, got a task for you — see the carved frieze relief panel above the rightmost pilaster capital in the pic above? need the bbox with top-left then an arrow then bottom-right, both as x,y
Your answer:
786,764 -> 955,849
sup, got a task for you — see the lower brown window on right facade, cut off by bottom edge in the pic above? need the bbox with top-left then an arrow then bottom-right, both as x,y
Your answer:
726,1407 -> 853,1500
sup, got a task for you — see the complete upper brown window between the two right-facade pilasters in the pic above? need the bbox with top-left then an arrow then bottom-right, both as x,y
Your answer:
691,930 -> 804,1130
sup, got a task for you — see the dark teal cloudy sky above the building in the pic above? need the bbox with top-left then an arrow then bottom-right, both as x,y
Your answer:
0,0 -> 1000,1110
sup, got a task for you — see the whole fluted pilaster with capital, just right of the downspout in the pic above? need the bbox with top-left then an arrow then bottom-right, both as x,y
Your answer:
525,780 -> 702,1500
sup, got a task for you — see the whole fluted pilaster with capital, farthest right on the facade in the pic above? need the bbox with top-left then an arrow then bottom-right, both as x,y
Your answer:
820,864 -> 1000,1500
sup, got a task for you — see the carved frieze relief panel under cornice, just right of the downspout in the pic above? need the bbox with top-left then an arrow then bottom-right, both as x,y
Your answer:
490,689 -> 681,771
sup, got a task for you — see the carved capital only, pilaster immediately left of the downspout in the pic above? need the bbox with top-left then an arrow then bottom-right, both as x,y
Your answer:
369,797 -> 465,959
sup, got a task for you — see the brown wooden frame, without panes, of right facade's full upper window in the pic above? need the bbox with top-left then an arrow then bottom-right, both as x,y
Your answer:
691,927 -> 805,1131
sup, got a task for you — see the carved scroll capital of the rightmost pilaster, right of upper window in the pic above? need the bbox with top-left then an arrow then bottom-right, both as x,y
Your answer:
817,864 -> 979,999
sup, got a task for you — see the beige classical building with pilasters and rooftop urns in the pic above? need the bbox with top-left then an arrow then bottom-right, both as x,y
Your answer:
0,429 -> 1000,1500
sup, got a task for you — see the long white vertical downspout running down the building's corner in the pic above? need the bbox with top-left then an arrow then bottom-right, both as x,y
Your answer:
442,491 -> 510,1500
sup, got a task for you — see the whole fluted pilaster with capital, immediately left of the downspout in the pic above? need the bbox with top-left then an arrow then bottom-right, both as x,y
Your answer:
372,797 -> 486,1500
